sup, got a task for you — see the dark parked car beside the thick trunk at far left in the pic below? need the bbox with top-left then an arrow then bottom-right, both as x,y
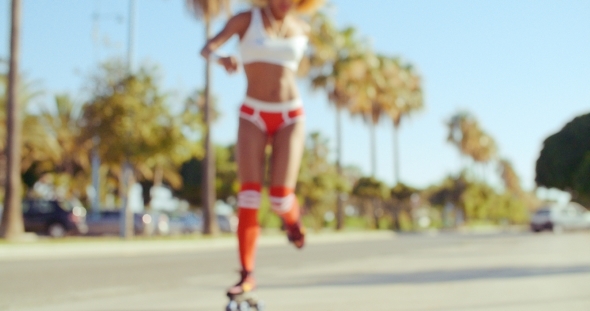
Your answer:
22,199 -> 88,237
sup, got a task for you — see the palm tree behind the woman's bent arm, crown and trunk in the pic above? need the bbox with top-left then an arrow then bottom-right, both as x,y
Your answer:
186,0 -> 230,234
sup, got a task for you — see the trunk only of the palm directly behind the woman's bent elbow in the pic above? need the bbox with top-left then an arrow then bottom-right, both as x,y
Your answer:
202,20 -> 217,235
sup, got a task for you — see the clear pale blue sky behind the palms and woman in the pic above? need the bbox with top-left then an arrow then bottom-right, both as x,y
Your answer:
0,0 -> 590,202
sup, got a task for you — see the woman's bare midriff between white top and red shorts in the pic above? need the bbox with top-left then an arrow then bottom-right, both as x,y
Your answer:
244,62 -> 299,103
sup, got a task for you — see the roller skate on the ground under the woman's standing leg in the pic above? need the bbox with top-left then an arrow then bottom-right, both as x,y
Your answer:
225,271 -> 264,311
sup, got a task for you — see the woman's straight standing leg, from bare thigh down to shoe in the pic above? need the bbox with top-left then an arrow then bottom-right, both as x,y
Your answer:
229,118 -> 267,294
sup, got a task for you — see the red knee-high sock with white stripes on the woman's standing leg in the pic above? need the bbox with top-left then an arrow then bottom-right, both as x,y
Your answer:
237,183 -> 261,272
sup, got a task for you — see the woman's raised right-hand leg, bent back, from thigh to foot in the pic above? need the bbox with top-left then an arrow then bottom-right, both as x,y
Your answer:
270,120 -> 305,248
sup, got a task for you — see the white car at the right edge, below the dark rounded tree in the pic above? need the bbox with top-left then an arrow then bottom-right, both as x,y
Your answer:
530,202 -> 590,233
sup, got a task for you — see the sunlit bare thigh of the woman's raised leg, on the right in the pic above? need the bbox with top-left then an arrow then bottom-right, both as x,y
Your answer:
270,120 -> 305,188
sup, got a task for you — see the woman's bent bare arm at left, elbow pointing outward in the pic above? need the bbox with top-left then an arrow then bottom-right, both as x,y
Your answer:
201,12 -> 250,73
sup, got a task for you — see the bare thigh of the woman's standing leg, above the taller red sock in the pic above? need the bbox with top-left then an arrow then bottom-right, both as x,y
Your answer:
236,118 -> 268,183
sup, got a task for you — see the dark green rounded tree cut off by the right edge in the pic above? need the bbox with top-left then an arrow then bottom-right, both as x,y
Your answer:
535,113 -> 590,207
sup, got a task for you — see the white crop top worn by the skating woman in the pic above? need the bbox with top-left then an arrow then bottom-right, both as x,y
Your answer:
240,8 -> 308,71
